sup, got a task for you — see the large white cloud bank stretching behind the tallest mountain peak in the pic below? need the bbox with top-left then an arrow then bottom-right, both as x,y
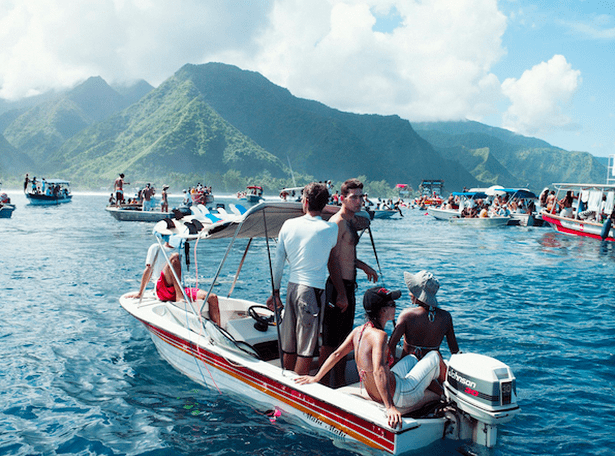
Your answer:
0,0 -> 506,124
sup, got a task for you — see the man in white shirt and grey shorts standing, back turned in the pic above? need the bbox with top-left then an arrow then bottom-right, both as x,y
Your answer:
267,182 -> 337,375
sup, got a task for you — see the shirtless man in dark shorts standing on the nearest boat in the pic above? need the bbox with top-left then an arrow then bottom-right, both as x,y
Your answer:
318,179 -> 378,386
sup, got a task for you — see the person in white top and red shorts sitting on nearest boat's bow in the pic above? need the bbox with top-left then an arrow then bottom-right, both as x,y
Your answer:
126,234 -> 220,325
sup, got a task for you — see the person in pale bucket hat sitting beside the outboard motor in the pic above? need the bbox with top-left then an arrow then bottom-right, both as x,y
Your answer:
389,271 -> 459,360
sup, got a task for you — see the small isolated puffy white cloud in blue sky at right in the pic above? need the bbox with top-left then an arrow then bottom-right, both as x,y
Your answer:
502,55 -> 581,135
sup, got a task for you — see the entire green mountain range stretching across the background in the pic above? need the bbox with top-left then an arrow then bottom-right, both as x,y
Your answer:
0,63 -> 606,191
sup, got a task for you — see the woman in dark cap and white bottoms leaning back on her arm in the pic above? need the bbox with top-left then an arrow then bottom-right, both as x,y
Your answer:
295,287 -> 446,428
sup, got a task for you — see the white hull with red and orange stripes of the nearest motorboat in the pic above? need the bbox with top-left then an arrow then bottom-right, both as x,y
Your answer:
120,298 -> 447,454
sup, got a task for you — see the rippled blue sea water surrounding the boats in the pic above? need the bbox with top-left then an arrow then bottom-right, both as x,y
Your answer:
0,192 -> 615,456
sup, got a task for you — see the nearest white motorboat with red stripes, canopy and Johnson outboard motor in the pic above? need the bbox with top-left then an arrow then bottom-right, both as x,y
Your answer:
120,202 -> 520,454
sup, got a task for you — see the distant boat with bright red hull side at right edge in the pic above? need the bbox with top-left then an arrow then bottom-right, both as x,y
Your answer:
541,184 -> 615,242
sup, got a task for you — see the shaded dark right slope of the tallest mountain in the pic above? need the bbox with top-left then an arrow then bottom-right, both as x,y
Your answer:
171,63 -> 476,188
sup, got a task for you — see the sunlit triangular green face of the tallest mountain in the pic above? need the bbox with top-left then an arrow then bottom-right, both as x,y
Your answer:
47,76 -> 286,187
